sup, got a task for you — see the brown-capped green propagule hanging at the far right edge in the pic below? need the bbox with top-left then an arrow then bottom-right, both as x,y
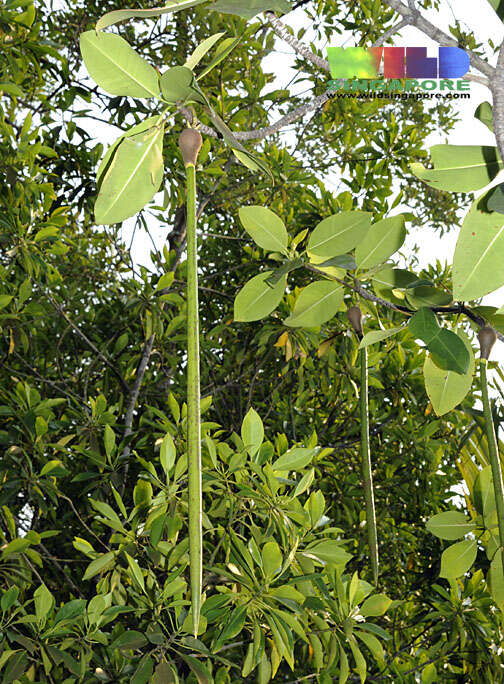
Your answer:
478,326 -> 504,568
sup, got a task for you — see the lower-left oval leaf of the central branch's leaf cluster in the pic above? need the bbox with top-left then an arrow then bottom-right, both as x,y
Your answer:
234,271 -> 287,322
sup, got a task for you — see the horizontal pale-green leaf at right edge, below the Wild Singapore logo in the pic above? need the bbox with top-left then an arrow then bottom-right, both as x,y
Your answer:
410,145 -> 503,192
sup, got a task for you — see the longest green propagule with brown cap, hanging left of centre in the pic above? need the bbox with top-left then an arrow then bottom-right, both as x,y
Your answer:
178,128 -> 203,637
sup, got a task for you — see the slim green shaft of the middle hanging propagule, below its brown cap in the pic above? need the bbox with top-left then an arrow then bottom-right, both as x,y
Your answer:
360,347 -> 378,585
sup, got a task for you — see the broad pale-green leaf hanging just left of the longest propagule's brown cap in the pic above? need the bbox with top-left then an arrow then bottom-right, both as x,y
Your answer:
95,124 -> 164,225
